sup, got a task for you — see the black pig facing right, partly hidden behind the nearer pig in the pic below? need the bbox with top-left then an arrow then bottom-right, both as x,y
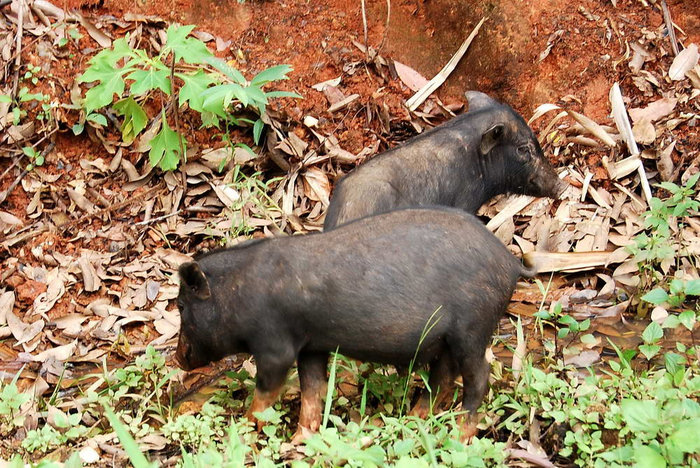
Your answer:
323,91 -> 565,230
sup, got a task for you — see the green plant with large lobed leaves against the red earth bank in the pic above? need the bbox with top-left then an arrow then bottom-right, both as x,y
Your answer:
74,25 -> 300,170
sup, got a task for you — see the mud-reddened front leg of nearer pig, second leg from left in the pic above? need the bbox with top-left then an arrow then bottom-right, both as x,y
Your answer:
292,351 -> 328,444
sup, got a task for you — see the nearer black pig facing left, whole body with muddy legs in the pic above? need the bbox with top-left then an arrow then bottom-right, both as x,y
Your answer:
175,208 -> 534,437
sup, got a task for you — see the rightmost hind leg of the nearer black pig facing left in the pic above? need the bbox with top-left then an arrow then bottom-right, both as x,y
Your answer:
461,353 -> 489,442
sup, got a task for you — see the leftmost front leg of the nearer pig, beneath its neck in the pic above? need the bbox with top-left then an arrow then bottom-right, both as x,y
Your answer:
246,348 -> 294,430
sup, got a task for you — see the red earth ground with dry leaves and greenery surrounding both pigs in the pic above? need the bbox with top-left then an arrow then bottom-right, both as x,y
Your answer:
0,0 -> 700,467
